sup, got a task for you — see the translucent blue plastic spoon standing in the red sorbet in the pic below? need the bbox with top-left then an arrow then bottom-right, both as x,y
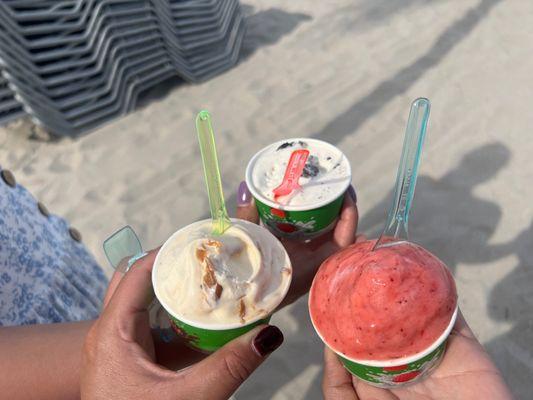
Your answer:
373,98 -> 430,250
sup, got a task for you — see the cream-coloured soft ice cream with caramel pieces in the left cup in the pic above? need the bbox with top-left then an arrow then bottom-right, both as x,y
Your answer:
154,219 -> 292,326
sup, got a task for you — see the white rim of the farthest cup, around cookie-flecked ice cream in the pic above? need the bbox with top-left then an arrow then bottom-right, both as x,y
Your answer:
245,137 -> 352,211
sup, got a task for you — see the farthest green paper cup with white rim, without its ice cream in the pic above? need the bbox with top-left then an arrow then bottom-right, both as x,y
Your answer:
246,138 -> 351,240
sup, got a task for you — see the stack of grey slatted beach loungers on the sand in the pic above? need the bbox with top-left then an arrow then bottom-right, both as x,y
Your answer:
0,0 -> 244,136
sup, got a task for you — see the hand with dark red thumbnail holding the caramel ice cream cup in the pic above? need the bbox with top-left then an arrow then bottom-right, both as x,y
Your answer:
81,251 -> 283,400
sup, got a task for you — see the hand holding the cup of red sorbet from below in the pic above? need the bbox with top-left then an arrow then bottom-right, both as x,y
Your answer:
322,313 -> 512,400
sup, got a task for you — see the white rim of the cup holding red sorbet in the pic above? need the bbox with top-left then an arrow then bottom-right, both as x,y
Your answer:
307,294 -> 459,367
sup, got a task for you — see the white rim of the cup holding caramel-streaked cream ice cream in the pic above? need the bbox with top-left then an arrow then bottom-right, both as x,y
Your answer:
152,218 -> 292,331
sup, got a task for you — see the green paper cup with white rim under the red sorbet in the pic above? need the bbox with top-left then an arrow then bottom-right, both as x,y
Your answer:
309,302 -> 458,389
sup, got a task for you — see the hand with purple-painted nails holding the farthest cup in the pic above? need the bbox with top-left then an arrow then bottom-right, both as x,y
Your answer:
237,182 -> 359,307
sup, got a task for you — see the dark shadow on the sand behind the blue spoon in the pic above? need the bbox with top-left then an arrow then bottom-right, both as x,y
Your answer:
359,143 -> 511,271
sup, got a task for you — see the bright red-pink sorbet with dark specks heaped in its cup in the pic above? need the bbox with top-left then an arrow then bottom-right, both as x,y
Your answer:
309,241 -> 457,360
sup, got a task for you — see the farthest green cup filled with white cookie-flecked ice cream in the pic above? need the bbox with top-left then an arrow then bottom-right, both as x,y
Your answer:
246,138 -> 351,240
